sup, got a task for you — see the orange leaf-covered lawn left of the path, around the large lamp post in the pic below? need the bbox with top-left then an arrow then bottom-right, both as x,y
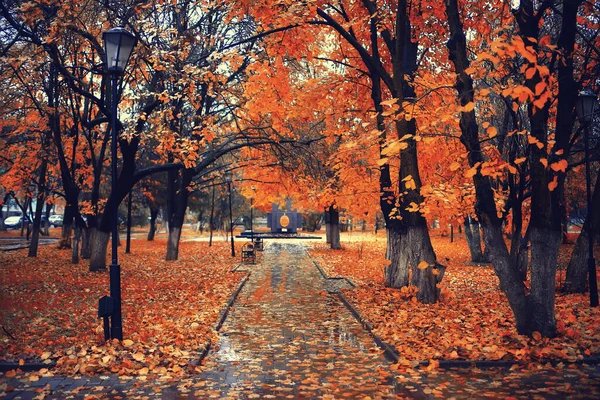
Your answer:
0,240 -> 243,376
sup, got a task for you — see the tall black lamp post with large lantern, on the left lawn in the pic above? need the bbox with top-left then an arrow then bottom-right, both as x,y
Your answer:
102,28 -> 137,340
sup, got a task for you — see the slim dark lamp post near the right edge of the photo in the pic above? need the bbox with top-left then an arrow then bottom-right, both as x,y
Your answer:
575,90 -> 598,307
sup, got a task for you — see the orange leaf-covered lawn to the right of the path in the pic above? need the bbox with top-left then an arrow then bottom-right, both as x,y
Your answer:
310,237 -> 600,365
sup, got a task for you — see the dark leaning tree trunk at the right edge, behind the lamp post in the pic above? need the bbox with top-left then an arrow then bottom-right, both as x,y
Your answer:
563,173 -> 600,293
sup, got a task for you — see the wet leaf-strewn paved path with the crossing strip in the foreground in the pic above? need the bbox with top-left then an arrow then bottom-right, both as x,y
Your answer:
0,241 -> 600,399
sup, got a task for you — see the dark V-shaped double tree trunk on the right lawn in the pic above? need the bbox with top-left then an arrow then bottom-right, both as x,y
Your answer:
445,0 -> 564,337
